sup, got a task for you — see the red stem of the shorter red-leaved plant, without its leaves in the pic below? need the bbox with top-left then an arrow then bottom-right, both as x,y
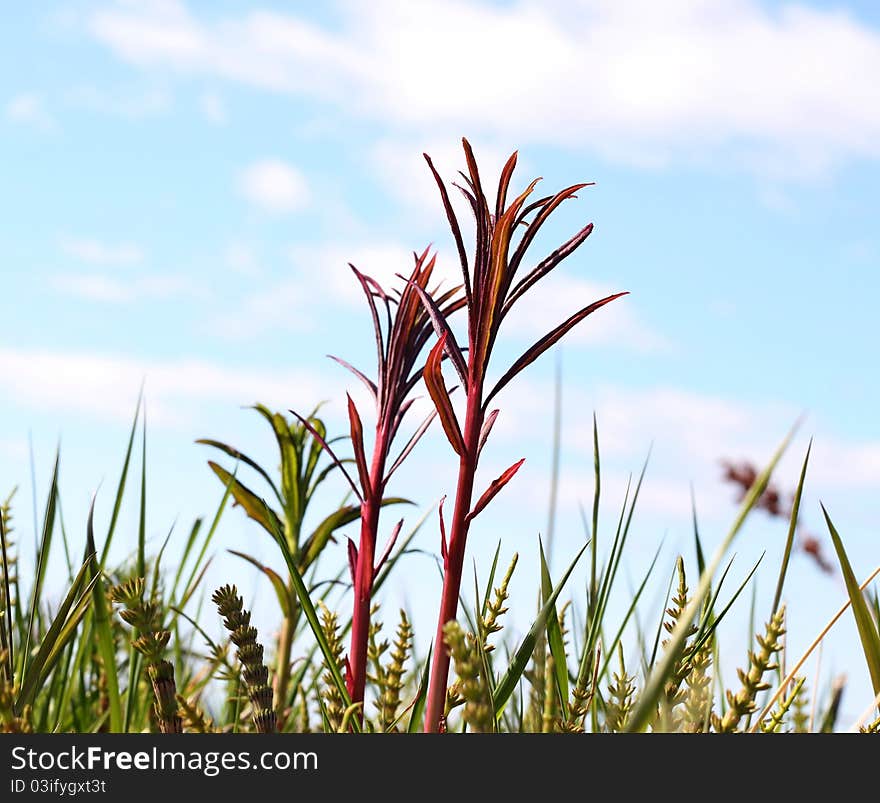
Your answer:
347,428 -> 388,721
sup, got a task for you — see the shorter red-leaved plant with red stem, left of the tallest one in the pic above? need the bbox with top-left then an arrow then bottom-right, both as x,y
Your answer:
303,250 -> 465,716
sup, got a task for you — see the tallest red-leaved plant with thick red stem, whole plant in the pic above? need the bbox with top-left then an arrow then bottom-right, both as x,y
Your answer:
416,139 -> 626,732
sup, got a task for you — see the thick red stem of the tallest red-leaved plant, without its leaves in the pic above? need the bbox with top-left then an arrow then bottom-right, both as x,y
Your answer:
425,383 -> 484,733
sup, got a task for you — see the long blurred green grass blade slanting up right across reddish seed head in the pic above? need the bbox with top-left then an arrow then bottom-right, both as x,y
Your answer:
626,424 -> 797,732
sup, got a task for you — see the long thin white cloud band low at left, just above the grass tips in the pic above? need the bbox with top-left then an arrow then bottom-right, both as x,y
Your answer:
0,348 -> 326,426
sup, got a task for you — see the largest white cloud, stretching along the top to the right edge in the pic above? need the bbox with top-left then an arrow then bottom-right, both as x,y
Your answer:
90,0 -> 880,177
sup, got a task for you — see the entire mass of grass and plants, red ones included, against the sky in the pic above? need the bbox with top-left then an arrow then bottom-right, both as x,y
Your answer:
0,142 -> 880,734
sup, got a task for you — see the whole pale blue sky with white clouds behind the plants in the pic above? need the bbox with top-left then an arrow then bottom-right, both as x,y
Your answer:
0,0 -> 880,716
